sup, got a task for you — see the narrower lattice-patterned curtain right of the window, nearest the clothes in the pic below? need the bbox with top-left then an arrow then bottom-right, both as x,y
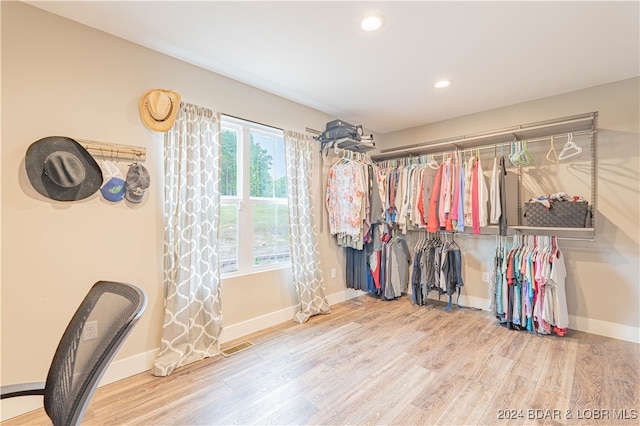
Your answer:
284,131 -> 331,323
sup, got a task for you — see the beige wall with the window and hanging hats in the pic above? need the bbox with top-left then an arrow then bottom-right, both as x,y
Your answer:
0,2 -> 356,417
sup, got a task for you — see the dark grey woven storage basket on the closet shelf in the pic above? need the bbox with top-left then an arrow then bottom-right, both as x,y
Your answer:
524,201 -> 589,228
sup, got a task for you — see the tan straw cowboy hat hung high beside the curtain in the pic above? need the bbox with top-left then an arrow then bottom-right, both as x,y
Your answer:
139,89 -> 180,132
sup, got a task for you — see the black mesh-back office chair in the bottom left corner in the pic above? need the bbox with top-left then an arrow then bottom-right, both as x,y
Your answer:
0,281 -> 147,425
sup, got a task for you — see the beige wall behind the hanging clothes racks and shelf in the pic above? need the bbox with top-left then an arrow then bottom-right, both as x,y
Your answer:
384,78 -> 640,332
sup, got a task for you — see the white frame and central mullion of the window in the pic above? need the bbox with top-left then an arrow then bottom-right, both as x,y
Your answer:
220,115 -> 291,277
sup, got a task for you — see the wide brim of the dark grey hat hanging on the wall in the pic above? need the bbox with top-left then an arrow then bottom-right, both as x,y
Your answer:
25,136 -> 102,201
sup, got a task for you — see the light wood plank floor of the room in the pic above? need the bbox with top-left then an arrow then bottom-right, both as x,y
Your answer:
3,296 -> 640,425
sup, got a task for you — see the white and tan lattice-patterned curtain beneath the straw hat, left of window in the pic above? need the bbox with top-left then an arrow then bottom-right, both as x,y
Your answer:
152,102 -> 222,376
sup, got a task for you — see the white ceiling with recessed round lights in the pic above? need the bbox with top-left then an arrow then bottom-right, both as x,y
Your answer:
26,1 -> 640,133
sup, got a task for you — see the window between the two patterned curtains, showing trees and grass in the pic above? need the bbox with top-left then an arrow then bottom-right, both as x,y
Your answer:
219,116 -> 291,273
